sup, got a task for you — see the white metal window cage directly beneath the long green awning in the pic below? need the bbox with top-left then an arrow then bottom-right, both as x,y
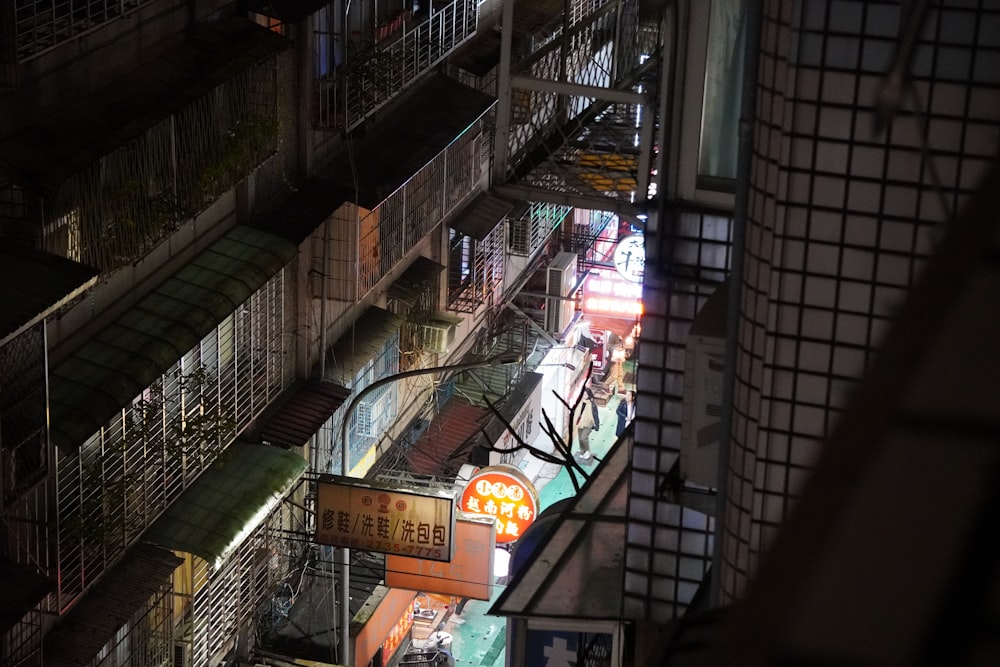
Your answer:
52,274 -> 288,610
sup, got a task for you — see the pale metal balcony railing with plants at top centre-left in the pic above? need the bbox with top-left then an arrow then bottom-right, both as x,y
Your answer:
316,0 -> 479,130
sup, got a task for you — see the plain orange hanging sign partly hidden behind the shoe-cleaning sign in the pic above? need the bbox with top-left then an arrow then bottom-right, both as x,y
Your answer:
385,512 -> 496,600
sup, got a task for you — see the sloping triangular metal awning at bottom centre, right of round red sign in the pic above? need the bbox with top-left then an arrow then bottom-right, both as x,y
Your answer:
488,438 -> 629,621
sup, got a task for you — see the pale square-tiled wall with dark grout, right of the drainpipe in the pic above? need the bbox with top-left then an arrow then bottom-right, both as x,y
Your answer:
720,0 -> 1000,599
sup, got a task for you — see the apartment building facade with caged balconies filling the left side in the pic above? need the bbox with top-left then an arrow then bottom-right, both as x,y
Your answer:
0,0 -> 588,665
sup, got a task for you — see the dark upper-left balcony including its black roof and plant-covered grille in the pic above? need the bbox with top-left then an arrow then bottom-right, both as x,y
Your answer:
0,19 -> 290,275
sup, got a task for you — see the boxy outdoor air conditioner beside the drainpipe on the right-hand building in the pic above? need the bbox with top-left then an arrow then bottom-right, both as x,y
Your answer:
680,284 -> 729,489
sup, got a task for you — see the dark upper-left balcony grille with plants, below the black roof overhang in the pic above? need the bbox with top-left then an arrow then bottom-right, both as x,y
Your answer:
42,57 -> 278,273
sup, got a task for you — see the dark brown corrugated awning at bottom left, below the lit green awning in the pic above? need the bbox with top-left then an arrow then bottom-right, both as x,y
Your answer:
44,544 -> 184,667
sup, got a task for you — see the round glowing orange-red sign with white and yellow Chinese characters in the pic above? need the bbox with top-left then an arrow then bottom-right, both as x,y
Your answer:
459,464 -> 538,544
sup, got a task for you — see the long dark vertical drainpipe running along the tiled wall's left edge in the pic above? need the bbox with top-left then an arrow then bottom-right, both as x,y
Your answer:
708,3 -> 763,607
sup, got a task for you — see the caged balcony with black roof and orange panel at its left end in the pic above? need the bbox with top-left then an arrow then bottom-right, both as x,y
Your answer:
329,74 -> 495,302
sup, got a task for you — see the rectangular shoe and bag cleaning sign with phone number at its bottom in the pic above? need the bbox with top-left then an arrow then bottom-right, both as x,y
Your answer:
316,475 -> 455,561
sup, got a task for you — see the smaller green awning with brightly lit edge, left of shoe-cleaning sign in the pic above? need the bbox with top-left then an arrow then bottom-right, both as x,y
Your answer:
143,442 -> 307,567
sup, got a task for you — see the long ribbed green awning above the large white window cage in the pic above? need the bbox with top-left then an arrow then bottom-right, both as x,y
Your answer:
50,226 -> 297,451
